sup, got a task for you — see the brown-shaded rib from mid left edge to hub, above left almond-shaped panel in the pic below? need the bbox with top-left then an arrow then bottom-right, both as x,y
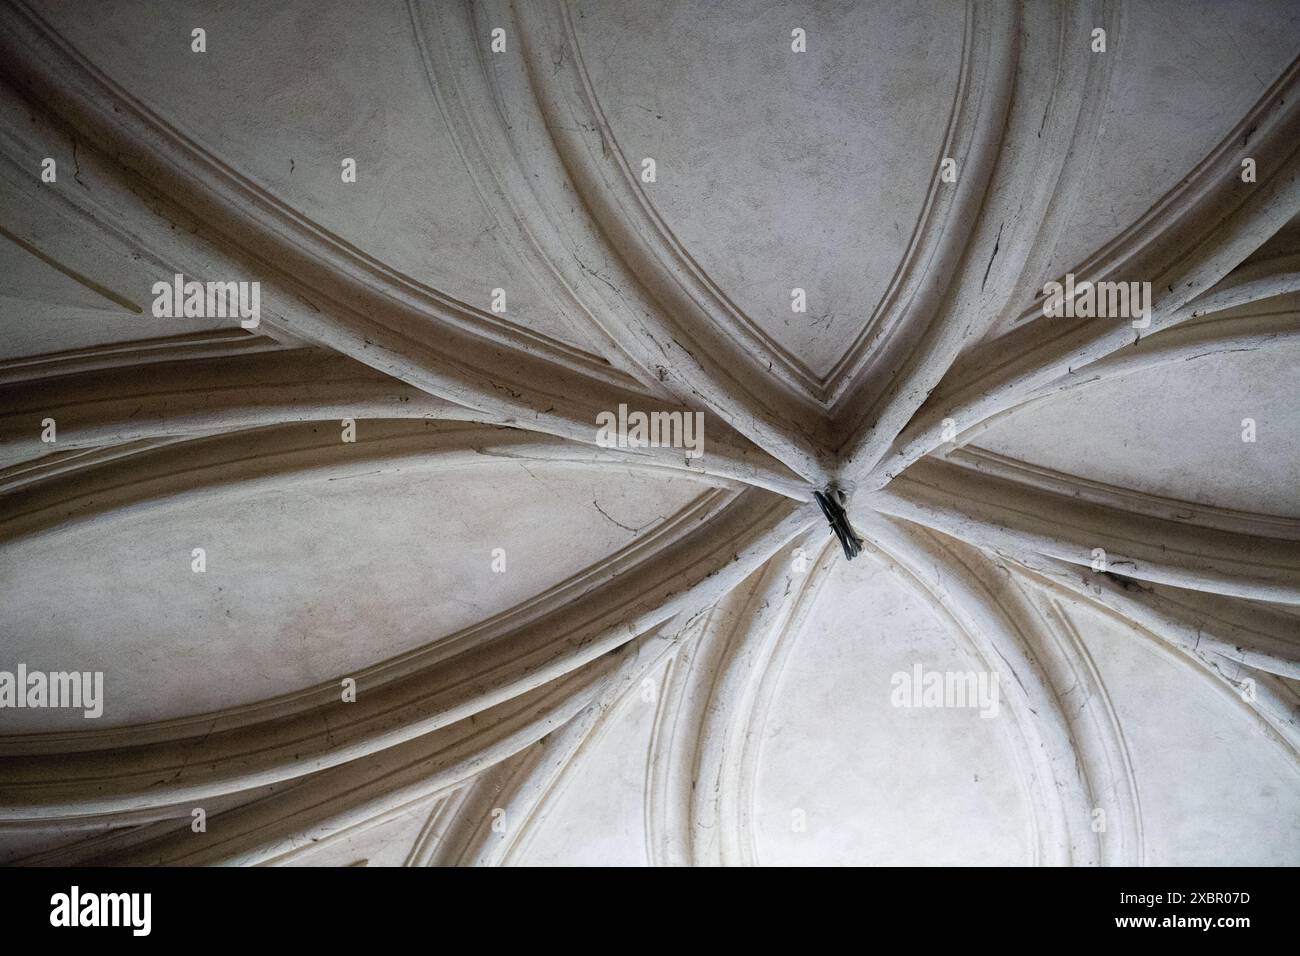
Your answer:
0,350 -> 809,502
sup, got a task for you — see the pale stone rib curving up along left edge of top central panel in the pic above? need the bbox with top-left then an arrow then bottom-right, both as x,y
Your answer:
493,0 -> 828,484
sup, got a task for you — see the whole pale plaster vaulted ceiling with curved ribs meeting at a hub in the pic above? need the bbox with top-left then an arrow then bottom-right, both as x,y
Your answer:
0,0 -> 1300,865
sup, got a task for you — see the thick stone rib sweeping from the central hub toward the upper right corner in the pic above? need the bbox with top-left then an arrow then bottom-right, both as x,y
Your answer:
863,59 -> 1300,488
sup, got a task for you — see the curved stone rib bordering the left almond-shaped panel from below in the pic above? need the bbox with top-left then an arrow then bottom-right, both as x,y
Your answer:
0,481 -> 815,821
